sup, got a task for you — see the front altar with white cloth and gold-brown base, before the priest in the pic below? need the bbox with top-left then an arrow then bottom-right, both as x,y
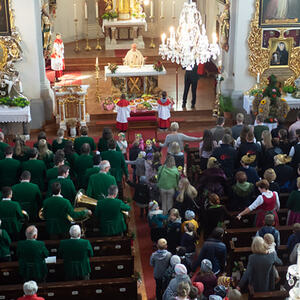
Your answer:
104,65 -> 167,96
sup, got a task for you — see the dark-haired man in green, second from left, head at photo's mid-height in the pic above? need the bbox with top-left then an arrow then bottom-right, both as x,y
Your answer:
22,148 -> 47,192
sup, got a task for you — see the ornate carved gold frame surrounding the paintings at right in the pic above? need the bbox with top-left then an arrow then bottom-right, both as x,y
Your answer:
248,0 -> 300,85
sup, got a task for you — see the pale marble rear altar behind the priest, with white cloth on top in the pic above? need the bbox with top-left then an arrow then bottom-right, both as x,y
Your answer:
102,19 -> 147,50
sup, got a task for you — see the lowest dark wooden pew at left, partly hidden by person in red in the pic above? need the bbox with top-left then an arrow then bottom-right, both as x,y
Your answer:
0,277 -> 137,300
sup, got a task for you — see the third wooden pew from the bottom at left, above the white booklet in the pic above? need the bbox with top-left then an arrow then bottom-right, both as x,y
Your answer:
10,236 -> 132,260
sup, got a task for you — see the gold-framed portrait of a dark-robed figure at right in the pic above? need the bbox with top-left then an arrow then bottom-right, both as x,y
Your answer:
269,38 -> 293,68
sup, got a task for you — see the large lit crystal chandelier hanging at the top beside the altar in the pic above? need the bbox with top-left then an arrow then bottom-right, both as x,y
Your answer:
159,0 -> 220,68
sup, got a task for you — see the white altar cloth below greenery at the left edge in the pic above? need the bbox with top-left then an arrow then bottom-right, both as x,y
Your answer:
0,105 -> 31,123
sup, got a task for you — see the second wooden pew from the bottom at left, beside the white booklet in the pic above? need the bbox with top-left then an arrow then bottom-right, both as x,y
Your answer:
0,255 -> 134,284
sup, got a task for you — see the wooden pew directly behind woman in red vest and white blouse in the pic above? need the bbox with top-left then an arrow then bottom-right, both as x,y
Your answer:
224,226 -> 293,249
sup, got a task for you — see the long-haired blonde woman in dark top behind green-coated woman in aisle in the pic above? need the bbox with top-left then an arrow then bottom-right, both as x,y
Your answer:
174,177 -> 198,216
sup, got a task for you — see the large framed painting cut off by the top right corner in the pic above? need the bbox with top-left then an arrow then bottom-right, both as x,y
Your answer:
259,0 -> 300,28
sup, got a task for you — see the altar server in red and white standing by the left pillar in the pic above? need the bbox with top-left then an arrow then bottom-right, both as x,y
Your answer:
51,33 -> 65,81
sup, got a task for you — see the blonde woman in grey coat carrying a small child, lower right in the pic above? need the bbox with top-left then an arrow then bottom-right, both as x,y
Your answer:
237,236 -> 282,292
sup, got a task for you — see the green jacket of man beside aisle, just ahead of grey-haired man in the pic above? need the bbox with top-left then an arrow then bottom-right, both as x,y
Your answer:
101,150 -> 128,182
